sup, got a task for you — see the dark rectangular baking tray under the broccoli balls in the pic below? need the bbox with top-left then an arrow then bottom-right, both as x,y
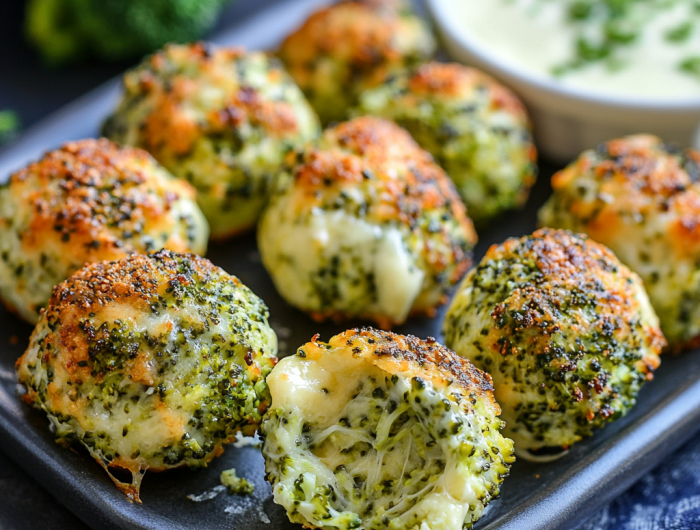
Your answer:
0,0 -> 700,530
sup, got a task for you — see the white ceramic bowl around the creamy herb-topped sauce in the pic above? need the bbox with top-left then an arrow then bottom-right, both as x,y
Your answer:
426,0 -> 700,162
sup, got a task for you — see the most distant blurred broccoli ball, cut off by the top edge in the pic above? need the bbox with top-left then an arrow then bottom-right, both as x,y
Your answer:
278,0 -> 435,124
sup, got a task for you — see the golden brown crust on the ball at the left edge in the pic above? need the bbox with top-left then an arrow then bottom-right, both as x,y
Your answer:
10,139 -> 195,262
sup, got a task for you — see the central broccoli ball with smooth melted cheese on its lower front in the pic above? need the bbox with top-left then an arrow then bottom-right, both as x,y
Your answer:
258,117 -> 476,328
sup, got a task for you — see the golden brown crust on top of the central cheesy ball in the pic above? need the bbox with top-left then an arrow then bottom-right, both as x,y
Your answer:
294,116 -> 476,244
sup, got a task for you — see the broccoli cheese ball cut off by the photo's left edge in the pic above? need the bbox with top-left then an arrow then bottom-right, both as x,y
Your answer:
0,139 -> 209,323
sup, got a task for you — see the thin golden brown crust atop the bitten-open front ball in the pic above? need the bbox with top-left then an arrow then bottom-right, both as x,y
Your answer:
299,328 -> 500,408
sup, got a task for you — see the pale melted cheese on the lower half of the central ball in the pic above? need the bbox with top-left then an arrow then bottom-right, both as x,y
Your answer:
258,203 -> 425,322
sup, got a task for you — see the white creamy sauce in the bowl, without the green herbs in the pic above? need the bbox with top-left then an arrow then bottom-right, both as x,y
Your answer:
436,0 -> 700,98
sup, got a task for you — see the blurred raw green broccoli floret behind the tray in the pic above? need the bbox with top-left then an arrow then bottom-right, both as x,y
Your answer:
25,0 -> 230,66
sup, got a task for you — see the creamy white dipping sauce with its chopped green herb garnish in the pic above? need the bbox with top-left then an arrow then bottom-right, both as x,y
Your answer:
436,0 -> 700,100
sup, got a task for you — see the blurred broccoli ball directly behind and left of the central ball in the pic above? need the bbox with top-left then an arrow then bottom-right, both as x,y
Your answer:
104,43 -> 319,239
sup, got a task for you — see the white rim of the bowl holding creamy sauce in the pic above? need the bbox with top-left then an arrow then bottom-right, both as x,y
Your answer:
425,0 -> 700,112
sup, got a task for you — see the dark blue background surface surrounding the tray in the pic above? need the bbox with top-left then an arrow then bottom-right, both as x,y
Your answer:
0,0 -> 700,530
